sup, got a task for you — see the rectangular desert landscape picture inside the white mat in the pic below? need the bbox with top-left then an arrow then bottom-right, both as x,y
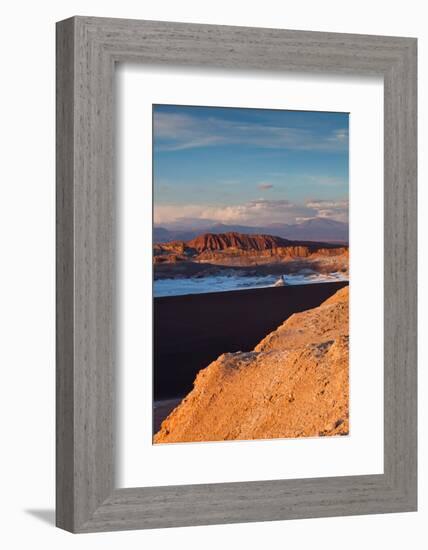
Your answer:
153,105 -> 349,444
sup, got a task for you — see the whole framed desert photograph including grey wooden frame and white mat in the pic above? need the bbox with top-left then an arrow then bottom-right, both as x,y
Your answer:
57,17 -> 417,533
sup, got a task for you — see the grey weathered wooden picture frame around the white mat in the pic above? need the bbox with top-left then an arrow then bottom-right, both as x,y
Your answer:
56,17 -> 417,532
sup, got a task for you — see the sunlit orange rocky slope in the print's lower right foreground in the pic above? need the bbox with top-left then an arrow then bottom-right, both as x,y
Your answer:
154,287 -> 349,443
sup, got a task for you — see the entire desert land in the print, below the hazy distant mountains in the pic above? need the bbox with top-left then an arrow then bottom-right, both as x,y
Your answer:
153,232 -> 349,443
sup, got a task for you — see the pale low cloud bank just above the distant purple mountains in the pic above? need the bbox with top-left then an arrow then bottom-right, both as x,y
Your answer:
155,199 -> 348,227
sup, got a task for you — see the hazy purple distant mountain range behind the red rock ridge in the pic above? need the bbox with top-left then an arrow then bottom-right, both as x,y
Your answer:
153,218 -> 349,243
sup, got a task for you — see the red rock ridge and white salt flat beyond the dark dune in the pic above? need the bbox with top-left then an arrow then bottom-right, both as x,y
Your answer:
153,232 -> 348,296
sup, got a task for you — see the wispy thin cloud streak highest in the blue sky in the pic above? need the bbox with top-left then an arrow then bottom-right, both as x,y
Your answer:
153,111 -> 348,152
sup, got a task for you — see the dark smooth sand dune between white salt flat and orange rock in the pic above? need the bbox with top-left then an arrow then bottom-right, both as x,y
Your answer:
153,282 -> 348,404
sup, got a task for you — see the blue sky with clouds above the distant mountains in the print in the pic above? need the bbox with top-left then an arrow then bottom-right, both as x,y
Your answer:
153,105 -> 349,227
